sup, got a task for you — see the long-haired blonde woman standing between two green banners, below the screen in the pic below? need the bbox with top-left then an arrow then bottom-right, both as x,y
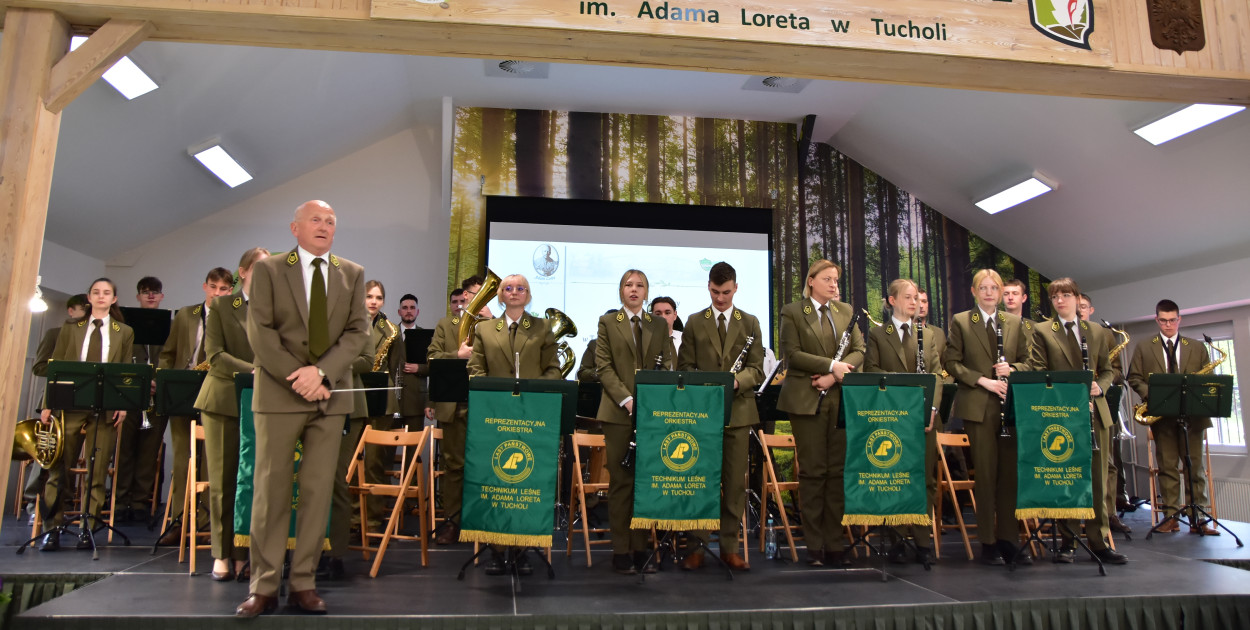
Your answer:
595,269 -> 673,575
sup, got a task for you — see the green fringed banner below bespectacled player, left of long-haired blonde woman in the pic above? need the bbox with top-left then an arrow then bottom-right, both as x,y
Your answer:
460,390 -> 563,548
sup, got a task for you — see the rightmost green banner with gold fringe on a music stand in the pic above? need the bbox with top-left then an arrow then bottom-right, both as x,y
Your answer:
1011,383 -> 1094,519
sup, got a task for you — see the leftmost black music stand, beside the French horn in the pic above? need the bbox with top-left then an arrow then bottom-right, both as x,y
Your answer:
18,361 -> 151,560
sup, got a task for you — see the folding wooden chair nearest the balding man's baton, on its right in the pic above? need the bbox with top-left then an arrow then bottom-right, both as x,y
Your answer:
348,426 -> 430,578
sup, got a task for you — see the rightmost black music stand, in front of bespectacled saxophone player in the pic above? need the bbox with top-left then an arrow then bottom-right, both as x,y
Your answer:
1146,374 -> 1244,546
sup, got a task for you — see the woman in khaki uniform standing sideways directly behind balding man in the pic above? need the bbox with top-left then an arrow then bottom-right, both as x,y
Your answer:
195,248 -> 269,581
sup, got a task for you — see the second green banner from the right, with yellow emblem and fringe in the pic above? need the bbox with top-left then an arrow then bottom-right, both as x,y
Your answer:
843,386 -> 933,525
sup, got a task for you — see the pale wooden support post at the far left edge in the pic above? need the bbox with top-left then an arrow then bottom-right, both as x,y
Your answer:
0,9 -> 70,532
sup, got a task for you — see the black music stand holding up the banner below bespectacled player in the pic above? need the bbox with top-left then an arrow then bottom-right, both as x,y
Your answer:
457,375 -> 578,594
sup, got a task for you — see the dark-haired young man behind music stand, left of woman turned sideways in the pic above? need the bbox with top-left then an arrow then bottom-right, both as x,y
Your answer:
159,268 -> 234,545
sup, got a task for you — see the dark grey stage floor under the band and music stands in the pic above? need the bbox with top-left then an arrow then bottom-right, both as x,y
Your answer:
0,510 -> 1250,628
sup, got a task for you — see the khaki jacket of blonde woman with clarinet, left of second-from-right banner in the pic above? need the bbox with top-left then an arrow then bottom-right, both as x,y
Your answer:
778,298 -> 864,415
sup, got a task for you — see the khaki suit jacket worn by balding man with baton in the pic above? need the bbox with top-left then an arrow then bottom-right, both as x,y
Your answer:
248,250 -> 369,415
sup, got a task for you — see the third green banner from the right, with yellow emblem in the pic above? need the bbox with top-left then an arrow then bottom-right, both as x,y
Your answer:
630,384 -> 725,530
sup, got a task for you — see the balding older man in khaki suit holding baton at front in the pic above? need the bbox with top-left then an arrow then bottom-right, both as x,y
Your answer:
235,201 -> 369,618
